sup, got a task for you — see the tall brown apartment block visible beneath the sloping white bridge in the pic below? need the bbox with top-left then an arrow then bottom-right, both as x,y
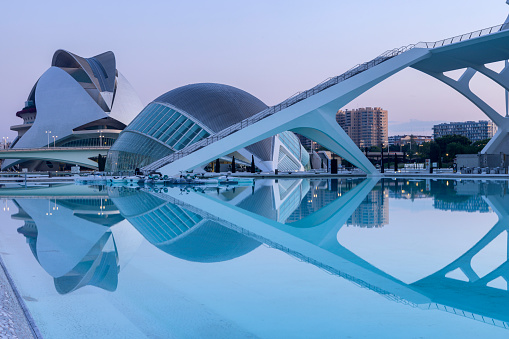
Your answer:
336,107 -> 389,148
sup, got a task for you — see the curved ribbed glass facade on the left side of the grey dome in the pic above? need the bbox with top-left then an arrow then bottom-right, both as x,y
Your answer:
106,102 -> 210,172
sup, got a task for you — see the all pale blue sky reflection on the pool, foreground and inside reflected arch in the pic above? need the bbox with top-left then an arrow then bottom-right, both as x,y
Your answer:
0,179 -> 507,338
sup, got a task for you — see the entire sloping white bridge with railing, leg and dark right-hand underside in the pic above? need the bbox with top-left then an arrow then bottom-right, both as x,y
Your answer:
150,26 -> 509,175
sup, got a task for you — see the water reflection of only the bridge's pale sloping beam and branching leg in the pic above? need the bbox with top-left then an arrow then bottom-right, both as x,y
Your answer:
151,179 -> 428,303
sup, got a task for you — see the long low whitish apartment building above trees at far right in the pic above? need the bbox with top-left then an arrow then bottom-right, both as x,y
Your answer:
433,120 -> 496,142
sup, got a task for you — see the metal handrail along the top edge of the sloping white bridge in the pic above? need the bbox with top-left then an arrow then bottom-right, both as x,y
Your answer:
141,23 -> 509,173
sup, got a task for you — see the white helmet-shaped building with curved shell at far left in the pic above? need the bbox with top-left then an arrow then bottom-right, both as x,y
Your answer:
2,50 -> 143,171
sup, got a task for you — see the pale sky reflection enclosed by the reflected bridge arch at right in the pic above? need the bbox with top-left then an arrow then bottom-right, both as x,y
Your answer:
338,199 -> 498,283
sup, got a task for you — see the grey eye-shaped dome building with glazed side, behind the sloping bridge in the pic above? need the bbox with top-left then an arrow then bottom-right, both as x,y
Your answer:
106,83 -> 309,171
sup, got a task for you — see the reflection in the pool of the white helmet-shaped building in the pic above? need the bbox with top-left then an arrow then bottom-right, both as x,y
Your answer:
12,187 -> 142,294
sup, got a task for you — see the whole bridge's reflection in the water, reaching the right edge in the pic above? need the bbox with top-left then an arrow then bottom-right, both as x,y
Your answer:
152,183 -> 509,328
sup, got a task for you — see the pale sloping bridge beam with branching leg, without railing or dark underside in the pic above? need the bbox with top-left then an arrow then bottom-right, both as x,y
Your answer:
159,48 -> 430,175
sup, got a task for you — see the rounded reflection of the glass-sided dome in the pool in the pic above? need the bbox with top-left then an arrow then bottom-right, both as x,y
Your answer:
108,188 -> 260,263
